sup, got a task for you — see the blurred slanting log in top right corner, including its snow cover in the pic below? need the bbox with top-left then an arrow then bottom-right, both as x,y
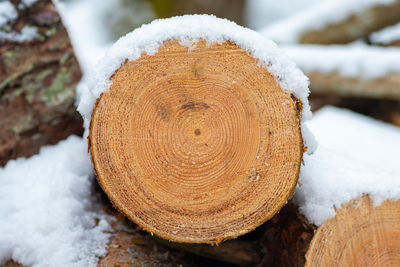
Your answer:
260,0 -> 400,44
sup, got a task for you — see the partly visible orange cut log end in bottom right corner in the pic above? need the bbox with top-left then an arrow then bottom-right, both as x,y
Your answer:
306,196 -> 400,267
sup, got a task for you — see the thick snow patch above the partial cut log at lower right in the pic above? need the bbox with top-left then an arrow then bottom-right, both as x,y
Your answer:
295,107 -> 400,225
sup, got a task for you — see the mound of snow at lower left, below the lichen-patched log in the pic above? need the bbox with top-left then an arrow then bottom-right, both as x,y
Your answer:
0,136 -> 110,267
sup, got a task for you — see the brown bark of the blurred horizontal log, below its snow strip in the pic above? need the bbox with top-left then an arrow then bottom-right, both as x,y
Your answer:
307,72 -> 400,100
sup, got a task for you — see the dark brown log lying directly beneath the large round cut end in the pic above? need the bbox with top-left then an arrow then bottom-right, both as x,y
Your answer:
97,205 -> 263,267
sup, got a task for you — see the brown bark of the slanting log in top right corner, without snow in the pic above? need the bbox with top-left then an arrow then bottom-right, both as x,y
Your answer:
299,0 -> 400,44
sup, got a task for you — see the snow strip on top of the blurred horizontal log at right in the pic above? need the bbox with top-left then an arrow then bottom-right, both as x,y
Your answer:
282,44 -> 400,79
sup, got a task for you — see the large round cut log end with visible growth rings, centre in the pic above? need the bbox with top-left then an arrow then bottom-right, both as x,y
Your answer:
90,41 -> 303,243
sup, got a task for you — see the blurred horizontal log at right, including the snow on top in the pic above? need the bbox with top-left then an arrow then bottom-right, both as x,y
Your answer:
284,45 -> 400,100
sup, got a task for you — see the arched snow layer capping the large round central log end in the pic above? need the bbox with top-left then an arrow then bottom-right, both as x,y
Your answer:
78,15 -> 315,151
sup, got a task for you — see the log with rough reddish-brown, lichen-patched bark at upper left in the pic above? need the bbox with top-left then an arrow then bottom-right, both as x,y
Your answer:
0,0 -> 82,166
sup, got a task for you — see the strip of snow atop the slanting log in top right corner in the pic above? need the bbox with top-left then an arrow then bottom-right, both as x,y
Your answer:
260,0 -> 396,44
